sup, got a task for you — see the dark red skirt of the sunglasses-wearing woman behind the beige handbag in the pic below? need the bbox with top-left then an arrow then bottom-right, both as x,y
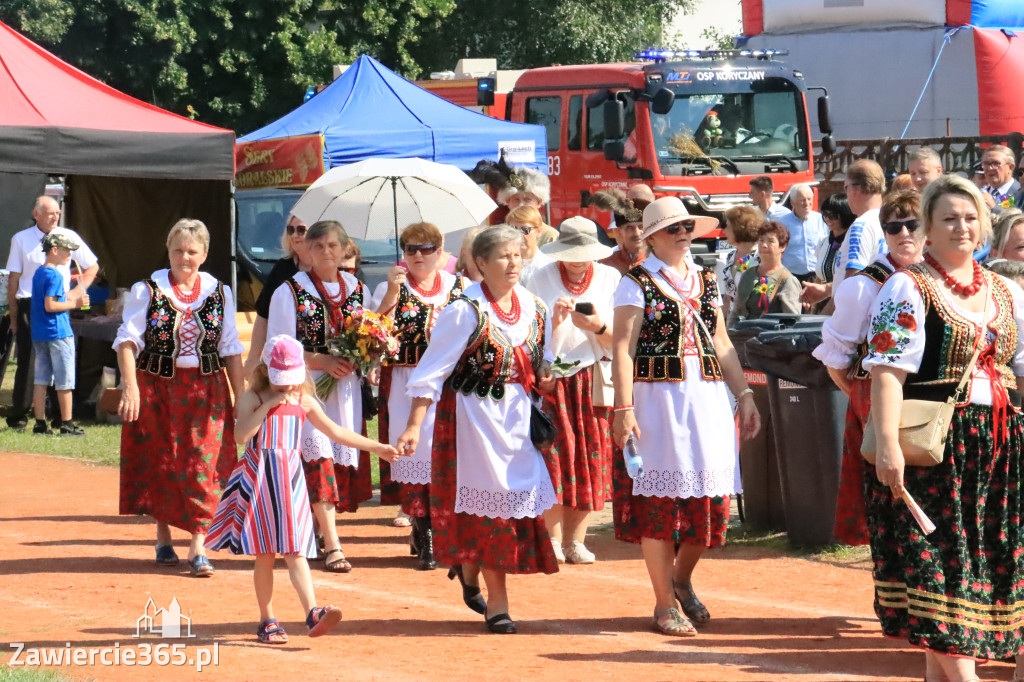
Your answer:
833,378 -> 871,545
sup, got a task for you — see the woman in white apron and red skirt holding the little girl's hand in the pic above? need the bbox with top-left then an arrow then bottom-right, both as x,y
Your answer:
396,225 -> 558,634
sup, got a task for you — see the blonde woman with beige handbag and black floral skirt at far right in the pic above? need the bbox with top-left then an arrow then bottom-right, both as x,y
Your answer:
863,175 -> 1024,682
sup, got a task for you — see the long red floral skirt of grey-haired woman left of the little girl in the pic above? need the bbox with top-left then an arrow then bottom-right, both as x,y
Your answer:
120,367 -> 239,534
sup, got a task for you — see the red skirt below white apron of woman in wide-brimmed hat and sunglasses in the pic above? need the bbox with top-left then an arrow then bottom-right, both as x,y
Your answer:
611,447 -> 729,547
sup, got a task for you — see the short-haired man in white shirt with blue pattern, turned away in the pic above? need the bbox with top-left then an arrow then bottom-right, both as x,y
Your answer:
831,159 -> 888,291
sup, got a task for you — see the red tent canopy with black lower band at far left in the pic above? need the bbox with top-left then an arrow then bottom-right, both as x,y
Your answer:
0,23 -> 234,180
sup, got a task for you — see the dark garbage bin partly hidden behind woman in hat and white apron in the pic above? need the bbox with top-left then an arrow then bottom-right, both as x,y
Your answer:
728,315 -> 797,531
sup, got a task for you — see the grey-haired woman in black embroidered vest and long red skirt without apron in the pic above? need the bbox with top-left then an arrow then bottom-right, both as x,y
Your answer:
114,218 -> 244,578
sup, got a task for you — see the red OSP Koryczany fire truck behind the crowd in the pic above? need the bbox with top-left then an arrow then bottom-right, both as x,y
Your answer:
418,50 -> 835,237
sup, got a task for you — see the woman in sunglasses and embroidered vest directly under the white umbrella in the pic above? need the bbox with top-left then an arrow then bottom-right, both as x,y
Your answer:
374,222 -> 465,570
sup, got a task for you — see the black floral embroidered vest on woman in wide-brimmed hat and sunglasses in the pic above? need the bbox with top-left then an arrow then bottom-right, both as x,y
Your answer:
626,266 -> 722,381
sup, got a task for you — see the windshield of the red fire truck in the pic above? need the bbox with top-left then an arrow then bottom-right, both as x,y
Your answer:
650,84 -> 809,175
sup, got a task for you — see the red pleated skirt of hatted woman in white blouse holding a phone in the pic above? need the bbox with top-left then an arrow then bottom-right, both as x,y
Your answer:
544,367 -> 611,511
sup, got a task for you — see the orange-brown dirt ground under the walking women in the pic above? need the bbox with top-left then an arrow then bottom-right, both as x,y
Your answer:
0,454 -> 1012,682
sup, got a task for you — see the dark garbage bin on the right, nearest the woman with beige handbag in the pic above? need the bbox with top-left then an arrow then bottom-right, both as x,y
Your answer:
745,315 -> 847,545
